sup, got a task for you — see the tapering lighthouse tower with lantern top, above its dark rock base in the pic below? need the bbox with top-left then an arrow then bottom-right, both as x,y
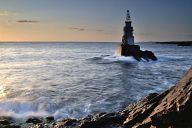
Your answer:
122,10 -> 134,45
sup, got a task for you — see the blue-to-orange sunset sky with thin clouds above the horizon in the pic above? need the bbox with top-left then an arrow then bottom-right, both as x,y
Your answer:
0,0 -> 192,42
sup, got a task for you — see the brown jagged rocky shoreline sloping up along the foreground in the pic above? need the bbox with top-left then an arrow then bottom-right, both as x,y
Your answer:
0,67 -> 192,128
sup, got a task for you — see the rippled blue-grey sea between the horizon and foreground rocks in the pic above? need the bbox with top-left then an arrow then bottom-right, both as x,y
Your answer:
0,42 -> 192,120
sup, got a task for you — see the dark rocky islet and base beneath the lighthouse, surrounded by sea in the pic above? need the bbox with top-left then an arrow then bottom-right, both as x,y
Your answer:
121,44 -> 157,61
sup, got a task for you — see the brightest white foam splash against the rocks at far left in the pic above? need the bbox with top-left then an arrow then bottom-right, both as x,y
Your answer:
0,97 -> 51,119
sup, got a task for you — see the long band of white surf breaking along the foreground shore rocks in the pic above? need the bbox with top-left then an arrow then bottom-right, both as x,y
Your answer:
0,97 -> 122,120
